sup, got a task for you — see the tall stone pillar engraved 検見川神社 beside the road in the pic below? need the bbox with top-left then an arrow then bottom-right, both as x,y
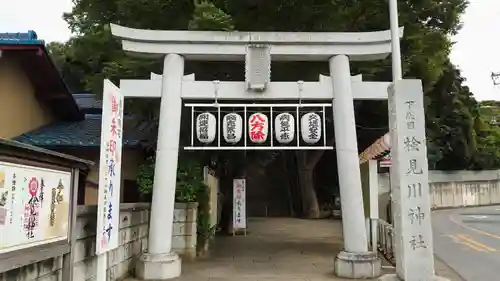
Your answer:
389,80 -> 434,281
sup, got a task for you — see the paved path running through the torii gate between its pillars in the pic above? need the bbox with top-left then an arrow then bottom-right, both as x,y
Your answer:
125,218 -> 462,281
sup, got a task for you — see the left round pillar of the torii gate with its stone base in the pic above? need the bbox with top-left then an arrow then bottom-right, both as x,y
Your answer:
136,54 -> 184,280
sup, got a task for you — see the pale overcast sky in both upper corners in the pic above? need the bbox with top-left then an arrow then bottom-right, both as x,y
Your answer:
0,0 -> 500,100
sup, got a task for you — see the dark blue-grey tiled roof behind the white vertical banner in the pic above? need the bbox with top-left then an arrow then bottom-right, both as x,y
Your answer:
14,114 -> 151,147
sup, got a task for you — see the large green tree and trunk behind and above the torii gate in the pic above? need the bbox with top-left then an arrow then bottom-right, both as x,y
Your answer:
47,0 -> 469,217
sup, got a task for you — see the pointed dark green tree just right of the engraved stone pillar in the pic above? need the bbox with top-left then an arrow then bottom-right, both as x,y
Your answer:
425,62 -> 477,170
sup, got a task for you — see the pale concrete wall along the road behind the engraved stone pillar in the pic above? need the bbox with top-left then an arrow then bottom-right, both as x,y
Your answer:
378,170 -> 500,219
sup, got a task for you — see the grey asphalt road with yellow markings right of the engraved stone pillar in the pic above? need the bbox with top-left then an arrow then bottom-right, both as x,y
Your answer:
432,203 -> 500,281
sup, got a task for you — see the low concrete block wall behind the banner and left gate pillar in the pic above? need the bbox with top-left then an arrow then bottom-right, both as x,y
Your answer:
0,203 -> 197,281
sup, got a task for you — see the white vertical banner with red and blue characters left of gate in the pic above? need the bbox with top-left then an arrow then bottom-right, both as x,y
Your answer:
96,80 -> 124,281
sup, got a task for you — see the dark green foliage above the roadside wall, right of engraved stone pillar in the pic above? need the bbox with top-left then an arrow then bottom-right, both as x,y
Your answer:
425,62 -> 500,170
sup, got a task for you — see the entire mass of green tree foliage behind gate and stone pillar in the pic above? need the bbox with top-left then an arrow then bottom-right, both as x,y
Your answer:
45,0 -> 500,215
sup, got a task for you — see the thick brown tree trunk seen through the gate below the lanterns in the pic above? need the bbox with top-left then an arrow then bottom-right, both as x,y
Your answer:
296,151 -> 324,219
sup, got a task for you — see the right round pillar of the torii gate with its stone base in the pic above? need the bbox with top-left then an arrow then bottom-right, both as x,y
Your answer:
330,55 -> 381,278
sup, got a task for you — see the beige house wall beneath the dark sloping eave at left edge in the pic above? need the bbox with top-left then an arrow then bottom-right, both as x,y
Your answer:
0,58 -> 53,139
